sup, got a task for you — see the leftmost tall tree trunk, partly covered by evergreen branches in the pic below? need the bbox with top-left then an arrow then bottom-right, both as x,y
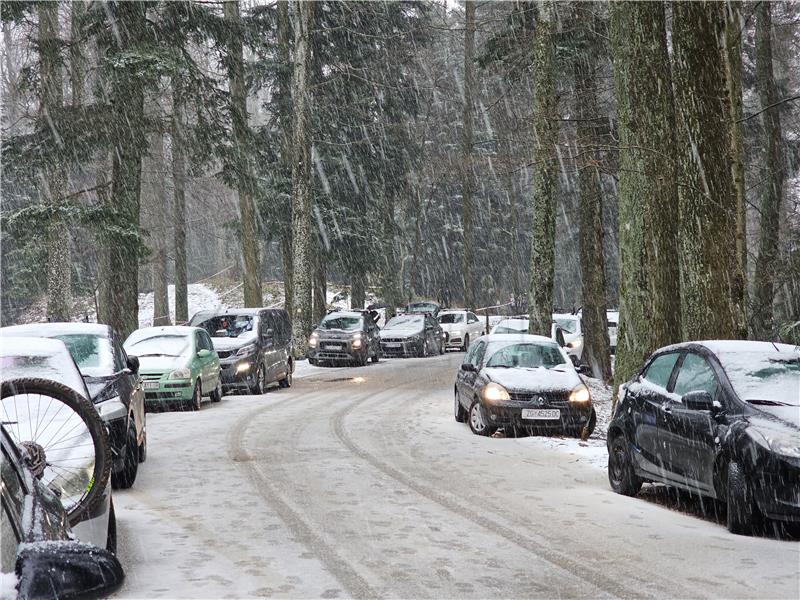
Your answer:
38,2 -> 72,321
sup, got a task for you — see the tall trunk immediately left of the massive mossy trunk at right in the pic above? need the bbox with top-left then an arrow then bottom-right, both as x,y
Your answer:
573,2 -> 611,381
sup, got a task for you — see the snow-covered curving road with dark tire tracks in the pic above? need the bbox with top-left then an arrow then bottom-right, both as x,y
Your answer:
114,354 -> 800,598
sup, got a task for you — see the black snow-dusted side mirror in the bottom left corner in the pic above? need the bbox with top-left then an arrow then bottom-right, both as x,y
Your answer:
16,541 -> 125,598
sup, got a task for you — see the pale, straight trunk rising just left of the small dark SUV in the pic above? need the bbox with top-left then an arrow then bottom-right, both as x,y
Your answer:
292,2 -> 314,357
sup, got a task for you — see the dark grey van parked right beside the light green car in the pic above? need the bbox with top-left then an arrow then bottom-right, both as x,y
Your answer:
189,308 -> 294,394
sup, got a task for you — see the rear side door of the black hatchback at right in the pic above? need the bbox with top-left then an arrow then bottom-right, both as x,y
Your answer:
625,352 -> 680,476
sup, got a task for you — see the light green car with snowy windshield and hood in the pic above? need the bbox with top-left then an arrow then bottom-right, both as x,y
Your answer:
123,327 -> 222,410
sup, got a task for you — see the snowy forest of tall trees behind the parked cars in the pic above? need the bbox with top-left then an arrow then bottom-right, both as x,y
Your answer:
0,0 -> 800,382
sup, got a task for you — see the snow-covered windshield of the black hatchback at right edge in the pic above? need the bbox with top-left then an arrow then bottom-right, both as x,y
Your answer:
719,352 -> 800,406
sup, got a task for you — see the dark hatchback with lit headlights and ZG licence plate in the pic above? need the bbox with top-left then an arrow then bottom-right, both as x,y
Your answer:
454,334 -> 596,436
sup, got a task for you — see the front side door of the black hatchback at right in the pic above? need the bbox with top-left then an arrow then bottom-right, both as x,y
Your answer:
659,351 -> 721,495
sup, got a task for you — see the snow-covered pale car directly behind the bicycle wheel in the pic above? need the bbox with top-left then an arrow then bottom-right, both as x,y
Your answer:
0,336 -> 116,552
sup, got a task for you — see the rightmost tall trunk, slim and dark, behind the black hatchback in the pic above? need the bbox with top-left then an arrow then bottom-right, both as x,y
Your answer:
753,2 -> 784,339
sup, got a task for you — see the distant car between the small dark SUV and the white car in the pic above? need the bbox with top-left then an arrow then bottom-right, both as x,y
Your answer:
380,313 -> 445,356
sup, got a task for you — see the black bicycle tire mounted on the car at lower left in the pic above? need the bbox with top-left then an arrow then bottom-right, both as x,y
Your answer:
0,377 -> 112,527
